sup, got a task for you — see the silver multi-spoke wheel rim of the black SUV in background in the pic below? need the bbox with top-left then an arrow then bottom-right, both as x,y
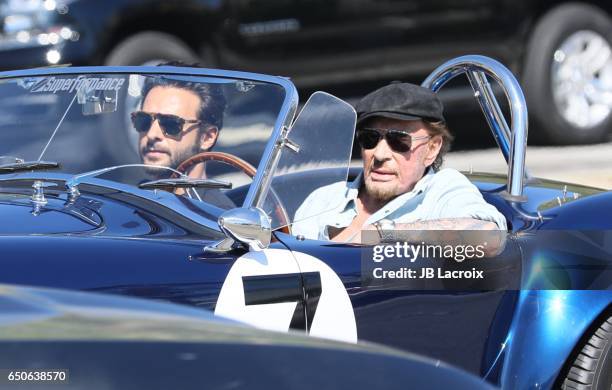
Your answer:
551,30 -> 612,129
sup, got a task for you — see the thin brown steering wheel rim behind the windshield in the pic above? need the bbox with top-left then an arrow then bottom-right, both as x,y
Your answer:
176,152 -> 291,234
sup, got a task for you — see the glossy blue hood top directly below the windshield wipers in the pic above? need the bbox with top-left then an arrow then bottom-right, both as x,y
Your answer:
0,180 -> 224,241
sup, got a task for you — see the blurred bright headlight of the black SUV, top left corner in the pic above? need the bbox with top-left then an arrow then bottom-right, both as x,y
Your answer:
0,0 -> 79,50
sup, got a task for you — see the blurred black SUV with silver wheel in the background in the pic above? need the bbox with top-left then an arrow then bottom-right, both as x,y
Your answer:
0,0 -> 612,144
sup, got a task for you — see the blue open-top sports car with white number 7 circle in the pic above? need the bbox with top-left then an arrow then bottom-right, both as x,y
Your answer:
0,56 -> 612,389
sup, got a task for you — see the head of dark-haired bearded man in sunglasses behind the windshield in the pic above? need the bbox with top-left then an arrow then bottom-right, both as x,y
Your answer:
131,64 -> 234,208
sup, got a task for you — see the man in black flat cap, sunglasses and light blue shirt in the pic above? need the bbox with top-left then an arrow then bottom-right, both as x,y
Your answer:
293,83 -> 507,242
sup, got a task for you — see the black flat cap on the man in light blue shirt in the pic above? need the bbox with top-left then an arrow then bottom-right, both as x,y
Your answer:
355,83 -> 445,123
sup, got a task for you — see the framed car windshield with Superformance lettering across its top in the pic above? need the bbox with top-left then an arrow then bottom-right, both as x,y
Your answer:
0,68 -> 289,209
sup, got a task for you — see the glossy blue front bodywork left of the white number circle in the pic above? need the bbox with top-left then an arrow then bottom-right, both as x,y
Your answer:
0,180 -> 239,300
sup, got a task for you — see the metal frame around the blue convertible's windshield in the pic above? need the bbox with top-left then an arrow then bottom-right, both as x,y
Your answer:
0,66 -> 299,231
